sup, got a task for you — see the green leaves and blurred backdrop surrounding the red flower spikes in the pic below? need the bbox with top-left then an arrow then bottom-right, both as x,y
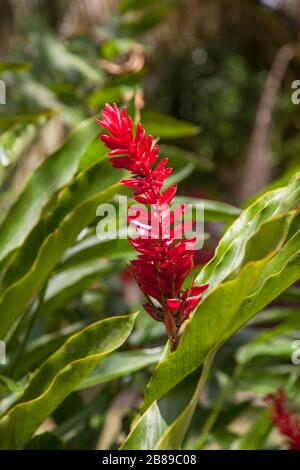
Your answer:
0,0 -> 300,449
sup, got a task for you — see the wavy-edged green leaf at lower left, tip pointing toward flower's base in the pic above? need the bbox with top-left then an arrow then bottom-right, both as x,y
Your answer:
0,315 -> 136,449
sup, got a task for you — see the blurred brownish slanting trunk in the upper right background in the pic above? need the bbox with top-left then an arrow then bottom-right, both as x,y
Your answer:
238,44 -> 296,202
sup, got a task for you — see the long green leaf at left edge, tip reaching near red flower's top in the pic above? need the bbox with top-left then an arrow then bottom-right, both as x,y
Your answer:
0,119 -> 96,261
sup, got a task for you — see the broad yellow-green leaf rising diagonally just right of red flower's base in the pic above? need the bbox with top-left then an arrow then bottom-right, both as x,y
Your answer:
142,262 -> 264,410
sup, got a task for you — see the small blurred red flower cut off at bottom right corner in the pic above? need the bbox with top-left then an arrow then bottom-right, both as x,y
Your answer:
266,390 -> 300,450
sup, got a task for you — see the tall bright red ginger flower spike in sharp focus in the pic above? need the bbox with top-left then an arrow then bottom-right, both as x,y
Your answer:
97,104 -> 208,350
